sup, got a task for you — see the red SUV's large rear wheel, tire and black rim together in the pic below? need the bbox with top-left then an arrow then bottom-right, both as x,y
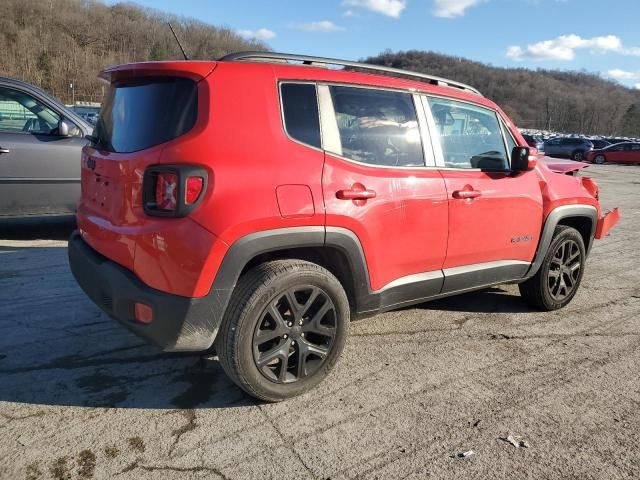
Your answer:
216,260 -> 350,402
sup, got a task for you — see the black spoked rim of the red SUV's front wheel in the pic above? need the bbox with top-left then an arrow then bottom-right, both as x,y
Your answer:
547,240 -> 582,301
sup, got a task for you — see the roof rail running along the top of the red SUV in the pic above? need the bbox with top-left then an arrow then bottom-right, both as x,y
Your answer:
218,51 -> 482,96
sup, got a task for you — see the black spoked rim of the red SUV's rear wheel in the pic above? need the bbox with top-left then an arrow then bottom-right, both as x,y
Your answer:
253,285 -> 338,383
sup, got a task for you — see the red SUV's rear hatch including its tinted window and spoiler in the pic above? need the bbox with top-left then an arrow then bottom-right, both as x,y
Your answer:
78,62 -> 215,270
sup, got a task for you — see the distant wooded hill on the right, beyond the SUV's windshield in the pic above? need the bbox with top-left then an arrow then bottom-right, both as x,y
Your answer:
365,50 -> 640,137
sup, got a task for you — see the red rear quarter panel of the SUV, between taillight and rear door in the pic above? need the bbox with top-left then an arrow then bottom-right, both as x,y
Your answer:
182,62 -> 325,245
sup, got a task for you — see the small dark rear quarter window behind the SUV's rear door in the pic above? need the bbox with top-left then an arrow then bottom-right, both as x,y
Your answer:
280,83 -> 321,148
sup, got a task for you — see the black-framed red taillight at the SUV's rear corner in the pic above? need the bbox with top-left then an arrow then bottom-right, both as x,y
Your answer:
142,165 -> 207,217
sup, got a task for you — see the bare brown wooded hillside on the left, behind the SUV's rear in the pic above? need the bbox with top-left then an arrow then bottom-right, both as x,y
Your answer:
0,0 -> 265,102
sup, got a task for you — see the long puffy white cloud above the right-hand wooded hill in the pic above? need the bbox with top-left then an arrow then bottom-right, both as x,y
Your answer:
507,35 -> 628,61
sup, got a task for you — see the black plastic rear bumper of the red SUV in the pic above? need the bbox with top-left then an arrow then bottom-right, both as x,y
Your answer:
69,231 -> 224,351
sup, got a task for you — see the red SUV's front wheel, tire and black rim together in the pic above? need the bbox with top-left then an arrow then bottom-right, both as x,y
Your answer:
518,225 -> 586,311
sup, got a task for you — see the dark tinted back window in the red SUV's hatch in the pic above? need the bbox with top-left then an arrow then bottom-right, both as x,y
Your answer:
94,77 -> 198,153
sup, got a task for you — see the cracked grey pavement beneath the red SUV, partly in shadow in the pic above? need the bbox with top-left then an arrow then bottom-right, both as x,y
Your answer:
0,165 -> 640,479
